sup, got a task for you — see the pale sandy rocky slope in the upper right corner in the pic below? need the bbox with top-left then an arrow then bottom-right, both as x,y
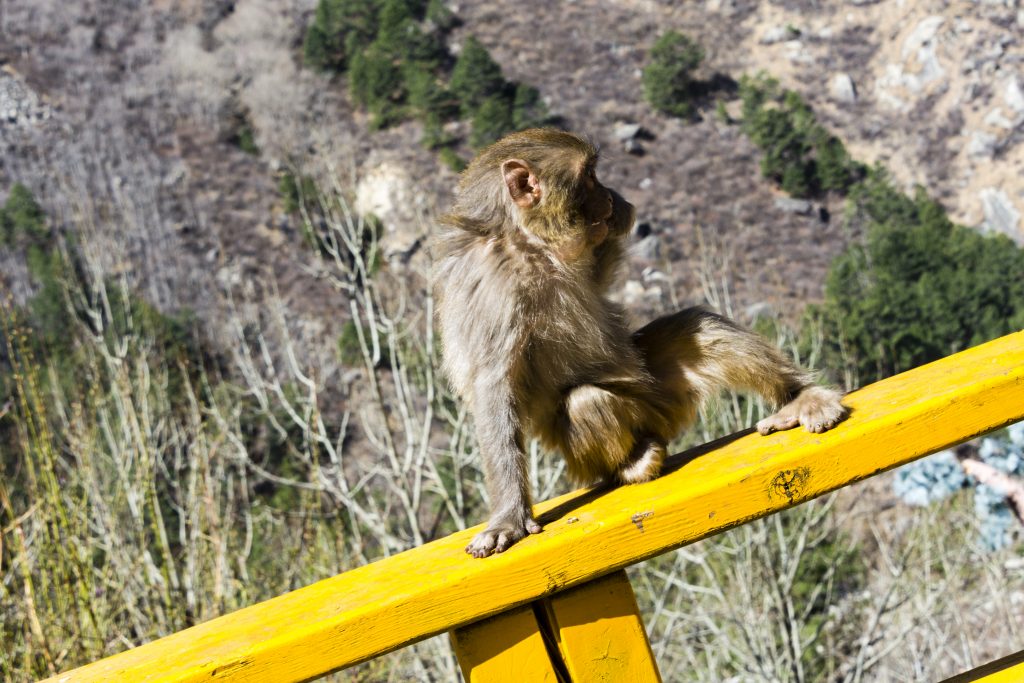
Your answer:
722,0 -> 1024,242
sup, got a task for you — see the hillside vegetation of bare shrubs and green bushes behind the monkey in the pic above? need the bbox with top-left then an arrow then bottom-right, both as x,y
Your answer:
0,0 -> 1024,681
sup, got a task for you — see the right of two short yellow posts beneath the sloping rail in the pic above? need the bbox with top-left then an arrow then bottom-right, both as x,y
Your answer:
543,569 -> 662,683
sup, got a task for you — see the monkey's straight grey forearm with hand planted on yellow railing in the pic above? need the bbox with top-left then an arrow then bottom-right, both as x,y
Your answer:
466,381 -> 541,557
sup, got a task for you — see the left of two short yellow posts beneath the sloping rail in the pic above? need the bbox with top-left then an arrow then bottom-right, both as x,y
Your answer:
451,605 -> 561,683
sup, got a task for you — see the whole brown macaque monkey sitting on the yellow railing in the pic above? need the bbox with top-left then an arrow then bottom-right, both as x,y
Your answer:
435,129 -> 846,557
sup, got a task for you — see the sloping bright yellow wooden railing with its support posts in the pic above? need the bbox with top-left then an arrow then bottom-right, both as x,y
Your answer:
50,332 -> 1024,683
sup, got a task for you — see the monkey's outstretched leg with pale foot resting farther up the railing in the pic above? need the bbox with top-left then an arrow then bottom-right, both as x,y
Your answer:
633,308 -> 846,434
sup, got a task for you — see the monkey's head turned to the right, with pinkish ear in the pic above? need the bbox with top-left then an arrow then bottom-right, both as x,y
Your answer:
447,128 -> 634,261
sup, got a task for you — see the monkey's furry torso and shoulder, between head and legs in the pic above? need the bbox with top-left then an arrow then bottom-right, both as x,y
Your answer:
436,228 -> 646,435
